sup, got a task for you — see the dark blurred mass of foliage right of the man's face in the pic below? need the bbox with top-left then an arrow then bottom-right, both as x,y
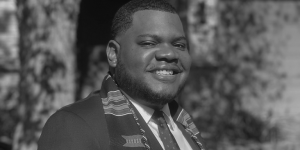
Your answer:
180,0 -> 283,149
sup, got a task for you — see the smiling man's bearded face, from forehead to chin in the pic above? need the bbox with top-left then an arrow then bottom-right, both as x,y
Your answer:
116,10 -> 191,108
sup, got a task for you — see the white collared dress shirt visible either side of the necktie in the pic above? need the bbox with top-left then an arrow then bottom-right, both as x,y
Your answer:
130,99 -> 192,150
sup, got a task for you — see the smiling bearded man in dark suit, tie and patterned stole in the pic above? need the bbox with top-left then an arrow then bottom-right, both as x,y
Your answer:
38,0 -> 204,150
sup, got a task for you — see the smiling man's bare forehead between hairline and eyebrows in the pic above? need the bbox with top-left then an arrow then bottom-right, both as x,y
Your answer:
127,10 -> 184,36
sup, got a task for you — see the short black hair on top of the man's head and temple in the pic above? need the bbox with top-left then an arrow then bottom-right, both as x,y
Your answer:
110,0 -> 177,39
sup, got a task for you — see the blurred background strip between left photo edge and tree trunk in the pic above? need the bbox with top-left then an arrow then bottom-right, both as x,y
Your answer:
0,3 -> 19,149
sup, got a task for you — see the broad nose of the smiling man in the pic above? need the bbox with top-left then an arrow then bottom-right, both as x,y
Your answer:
155,45 -> 179,62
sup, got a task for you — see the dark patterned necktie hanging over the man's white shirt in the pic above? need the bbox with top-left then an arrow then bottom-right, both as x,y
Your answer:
152,111 -> 180,150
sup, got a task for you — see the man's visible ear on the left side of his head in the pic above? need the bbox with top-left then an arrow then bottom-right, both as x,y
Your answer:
106,40 -> 120,68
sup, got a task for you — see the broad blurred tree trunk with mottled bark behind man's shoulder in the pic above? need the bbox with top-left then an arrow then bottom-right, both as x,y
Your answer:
13,0 -> 79,149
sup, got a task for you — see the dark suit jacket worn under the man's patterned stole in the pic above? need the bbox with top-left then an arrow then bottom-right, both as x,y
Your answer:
38,94 -> 199,150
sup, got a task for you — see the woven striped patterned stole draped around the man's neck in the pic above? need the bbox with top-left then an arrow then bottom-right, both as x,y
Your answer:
100,75 -> 204,150
